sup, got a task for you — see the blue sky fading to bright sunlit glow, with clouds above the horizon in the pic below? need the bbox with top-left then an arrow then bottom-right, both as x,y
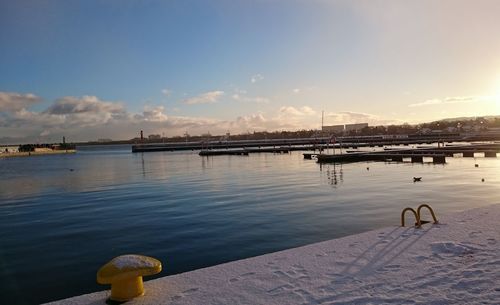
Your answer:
0,0 -> 500,142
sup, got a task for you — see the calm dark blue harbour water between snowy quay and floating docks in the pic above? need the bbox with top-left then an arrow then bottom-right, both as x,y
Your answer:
0,146 -> 500,304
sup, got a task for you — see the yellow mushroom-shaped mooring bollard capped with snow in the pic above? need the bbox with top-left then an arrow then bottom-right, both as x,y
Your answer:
97,254 -> 161,302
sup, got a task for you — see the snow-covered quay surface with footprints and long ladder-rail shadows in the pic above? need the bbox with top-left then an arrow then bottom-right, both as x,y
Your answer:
45,205 -> 500,305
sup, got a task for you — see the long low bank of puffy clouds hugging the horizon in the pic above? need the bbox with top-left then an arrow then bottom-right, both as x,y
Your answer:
0,94 -> 400,143
